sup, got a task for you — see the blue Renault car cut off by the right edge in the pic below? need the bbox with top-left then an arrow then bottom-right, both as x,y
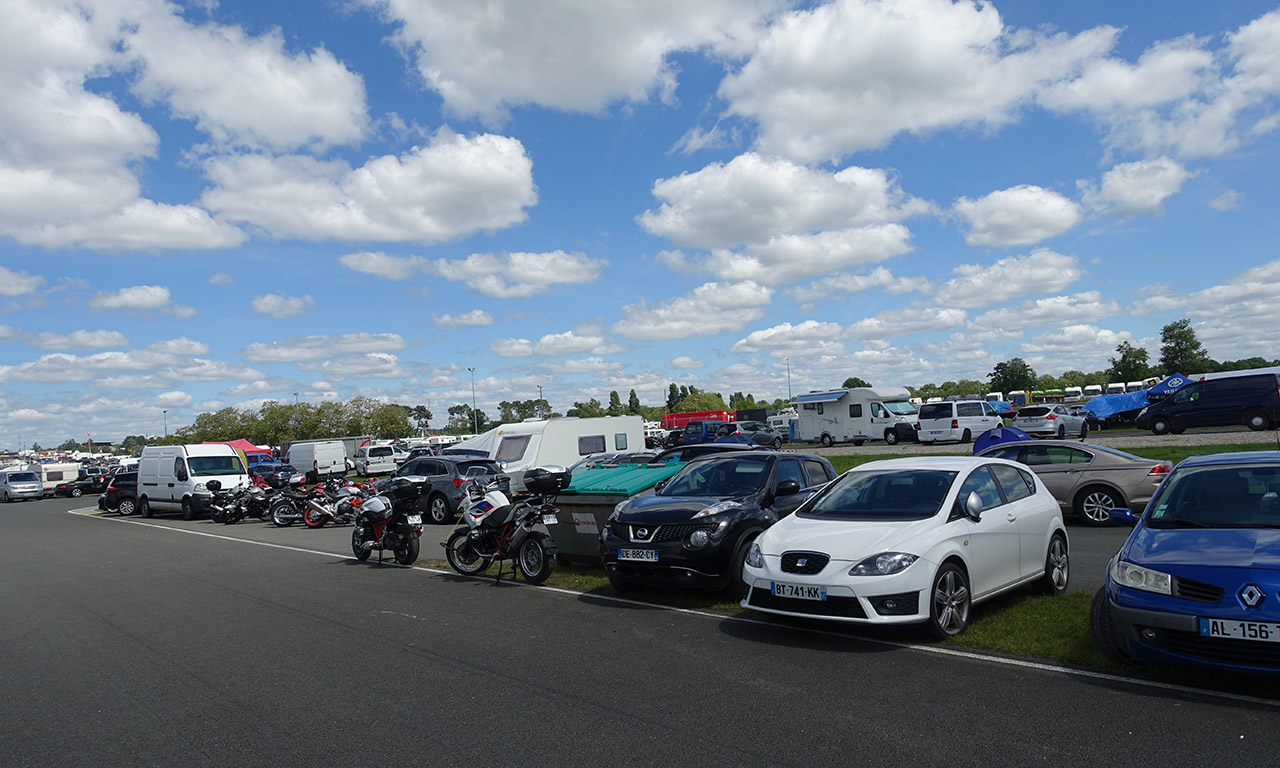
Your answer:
1089,451 -> 1280,675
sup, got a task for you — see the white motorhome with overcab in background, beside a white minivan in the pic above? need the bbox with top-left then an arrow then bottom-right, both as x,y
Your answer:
794,387 -> 916,445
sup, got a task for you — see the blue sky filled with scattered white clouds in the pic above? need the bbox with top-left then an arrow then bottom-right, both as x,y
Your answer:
0,0 -> 1280,447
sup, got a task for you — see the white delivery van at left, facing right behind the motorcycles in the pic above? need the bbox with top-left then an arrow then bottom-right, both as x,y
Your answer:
138,443 -> 248,520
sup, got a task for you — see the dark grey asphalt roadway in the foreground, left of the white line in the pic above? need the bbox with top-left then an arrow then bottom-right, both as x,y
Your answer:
0,500 -> 1280,767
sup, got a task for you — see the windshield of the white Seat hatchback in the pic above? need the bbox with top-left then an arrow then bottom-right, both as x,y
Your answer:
797,470 -> 956,521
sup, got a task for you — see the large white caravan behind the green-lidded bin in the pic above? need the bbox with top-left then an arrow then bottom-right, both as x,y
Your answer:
454,416 -> 644,492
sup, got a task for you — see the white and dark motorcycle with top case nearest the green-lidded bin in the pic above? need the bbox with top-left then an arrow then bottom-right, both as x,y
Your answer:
442,467 -> 570,584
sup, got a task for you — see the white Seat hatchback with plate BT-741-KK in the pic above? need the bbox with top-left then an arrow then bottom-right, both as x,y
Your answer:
741,456 -> 1070,637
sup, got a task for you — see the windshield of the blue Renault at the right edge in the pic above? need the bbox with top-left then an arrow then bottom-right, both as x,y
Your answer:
1147,465 -> 1280,529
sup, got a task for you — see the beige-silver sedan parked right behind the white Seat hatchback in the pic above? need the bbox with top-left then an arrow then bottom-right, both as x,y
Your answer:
979,440 -> 1172,525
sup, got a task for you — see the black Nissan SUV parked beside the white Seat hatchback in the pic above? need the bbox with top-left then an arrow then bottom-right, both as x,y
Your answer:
600,451 -> 836,596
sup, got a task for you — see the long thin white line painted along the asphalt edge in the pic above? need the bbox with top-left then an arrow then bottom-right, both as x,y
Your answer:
67,509 -> 1280,708
